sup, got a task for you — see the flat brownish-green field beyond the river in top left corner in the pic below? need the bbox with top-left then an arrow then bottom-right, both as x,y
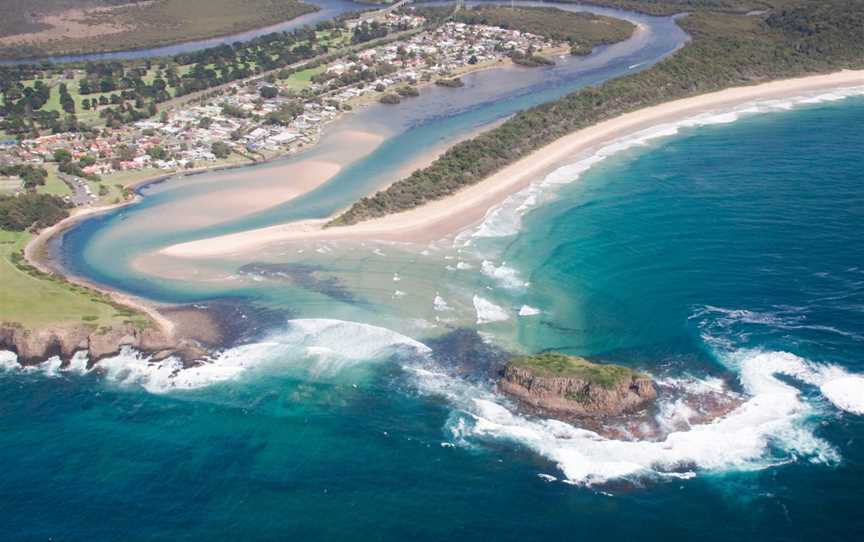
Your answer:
0,0 -> 316,58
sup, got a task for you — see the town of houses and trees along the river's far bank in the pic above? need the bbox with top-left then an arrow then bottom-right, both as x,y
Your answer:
0,11 -> 568,210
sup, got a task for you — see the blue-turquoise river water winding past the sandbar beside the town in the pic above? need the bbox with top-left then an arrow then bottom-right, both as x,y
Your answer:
55,2 -> 687,301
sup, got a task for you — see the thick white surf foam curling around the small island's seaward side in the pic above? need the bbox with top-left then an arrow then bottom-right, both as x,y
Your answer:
413,351 -> 864,485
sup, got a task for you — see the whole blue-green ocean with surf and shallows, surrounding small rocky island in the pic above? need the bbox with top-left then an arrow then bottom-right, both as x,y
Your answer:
0,70 -> 864,541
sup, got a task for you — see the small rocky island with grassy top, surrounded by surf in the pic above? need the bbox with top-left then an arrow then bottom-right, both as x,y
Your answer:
498,354 -> 657,418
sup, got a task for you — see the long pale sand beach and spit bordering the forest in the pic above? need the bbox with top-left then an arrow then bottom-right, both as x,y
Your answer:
161,70 -> 864,258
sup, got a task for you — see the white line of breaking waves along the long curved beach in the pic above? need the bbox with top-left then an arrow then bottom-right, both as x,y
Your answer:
470,87 -> 864,242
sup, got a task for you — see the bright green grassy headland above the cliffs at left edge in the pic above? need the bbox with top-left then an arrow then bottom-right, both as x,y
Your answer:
0,230 -> 147,328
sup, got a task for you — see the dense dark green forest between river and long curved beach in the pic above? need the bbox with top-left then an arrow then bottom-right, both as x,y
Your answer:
330,0 -> 864,225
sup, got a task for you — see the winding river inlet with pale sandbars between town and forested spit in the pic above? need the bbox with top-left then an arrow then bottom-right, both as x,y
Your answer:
53,2 -> 687,310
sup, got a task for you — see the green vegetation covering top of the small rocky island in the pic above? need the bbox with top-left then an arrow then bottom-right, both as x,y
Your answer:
507,352 -> 645,388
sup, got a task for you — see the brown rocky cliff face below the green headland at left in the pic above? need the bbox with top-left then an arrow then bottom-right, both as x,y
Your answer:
0,324 -> 206,365
